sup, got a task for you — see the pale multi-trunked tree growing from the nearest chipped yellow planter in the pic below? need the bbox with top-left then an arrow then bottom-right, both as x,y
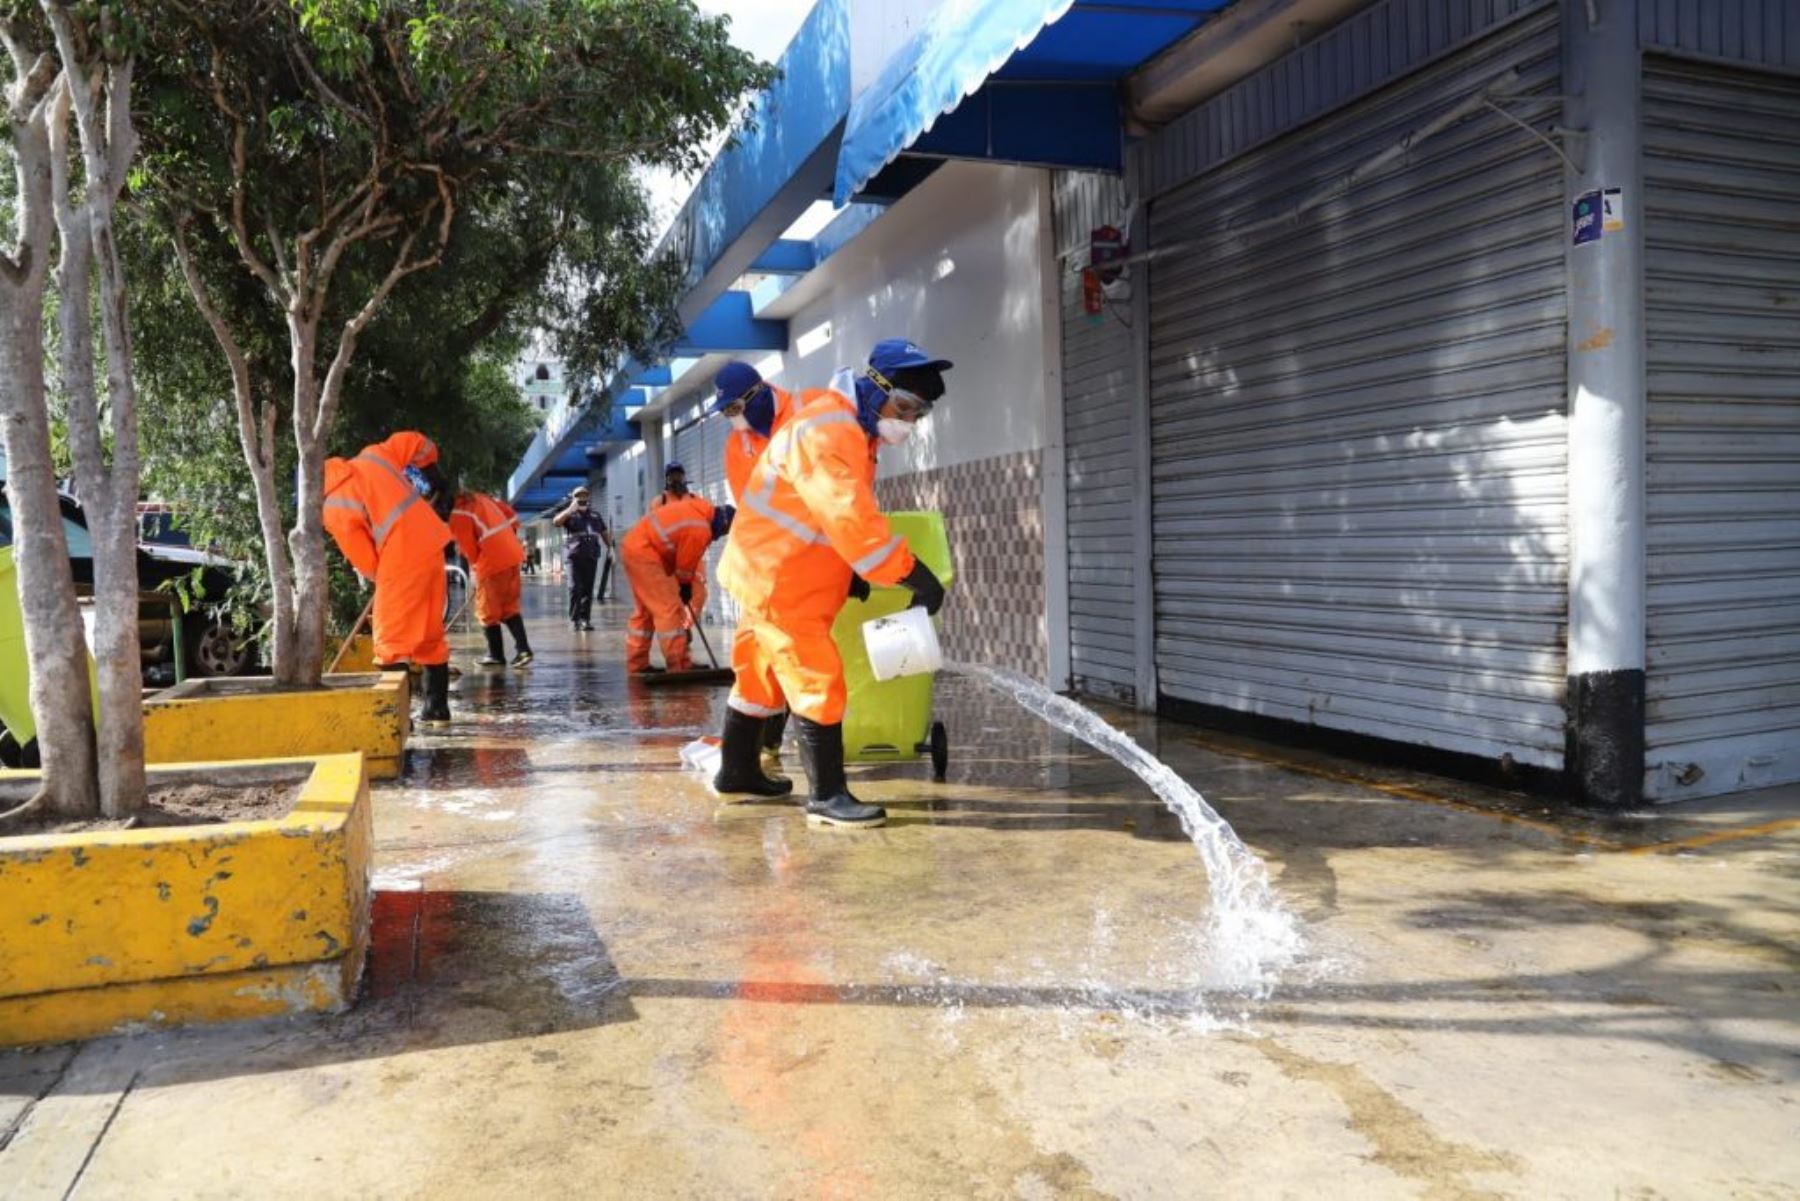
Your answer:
0,0 -> 144,817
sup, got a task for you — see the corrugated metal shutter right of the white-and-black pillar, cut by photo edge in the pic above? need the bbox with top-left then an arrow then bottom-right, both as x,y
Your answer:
1643,58 -> 1800,799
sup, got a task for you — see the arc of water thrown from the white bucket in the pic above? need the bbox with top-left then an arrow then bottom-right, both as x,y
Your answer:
943,663 -> 1300,998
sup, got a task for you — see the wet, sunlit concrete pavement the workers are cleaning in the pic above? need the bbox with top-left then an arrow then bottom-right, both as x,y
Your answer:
0,585 -> 1800,1199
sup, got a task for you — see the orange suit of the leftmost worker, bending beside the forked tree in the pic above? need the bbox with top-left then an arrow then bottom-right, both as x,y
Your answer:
324,430 -> 450,666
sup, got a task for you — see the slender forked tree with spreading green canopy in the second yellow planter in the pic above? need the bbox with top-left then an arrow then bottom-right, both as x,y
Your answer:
146,0 -> 767,686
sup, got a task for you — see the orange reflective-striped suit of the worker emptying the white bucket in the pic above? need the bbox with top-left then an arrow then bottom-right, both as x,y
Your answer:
718,391 -> 913,726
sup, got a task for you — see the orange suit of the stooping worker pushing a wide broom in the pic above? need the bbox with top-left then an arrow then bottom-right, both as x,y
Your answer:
619,493 -> 713,672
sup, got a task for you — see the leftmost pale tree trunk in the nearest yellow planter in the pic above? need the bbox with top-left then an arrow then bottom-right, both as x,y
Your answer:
0,84 -> 99,817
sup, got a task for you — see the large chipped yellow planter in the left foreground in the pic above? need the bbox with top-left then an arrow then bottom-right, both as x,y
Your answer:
0,754 -> 373,1046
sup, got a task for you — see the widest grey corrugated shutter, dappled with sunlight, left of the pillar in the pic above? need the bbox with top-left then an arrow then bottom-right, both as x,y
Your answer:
1150,9 -> 1568,767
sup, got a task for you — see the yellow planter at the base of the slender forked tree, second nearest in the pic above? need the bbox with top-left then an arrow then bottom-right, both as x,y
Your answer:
144,672 -> 410,780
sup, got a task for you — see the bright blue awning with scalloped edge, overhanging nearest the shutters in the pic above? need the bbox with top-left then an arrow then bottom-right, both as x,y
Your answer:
833,0 -> 1231,203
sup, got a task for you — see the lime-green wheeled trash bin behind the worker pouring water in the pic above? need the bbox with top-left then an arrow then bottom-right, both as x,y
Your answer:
832,513 -> 956,780
